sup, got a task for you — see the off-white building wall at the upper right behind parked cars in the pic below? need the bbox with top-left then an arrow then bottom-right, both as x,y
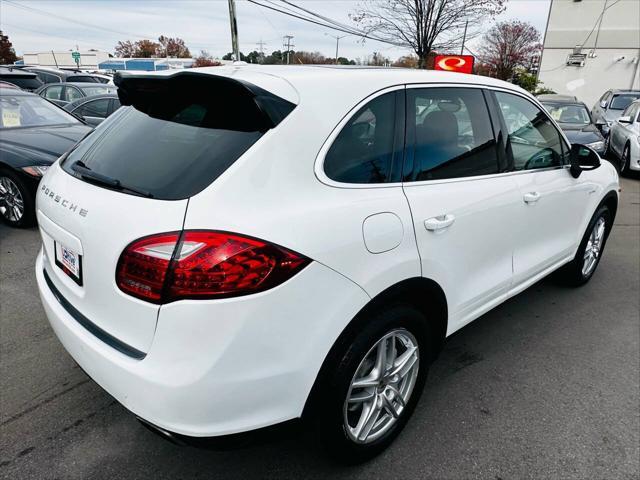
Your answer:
540,0 -> 640,107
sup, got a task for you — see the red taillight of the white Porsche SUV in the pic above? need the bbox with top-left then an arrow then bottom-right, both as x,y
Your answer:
116,230 -> 310,303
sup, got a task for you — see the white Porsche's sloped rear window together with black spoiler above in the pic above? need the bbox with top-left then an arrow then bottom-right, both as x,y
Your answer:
62,74 -> 295,200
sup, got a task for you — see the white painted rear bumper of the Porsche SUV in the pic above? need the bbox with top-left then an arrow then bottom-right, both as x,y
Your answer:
36,253 -> 369,437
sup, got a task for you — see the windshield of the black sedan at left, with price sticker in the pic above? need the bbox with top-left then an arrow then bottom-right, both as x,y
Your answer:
0,95 -> 80,128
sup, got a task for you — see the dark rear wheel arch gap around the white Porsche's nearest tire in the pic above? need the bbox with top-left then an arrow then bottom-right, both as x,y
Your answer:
302,277 -> 448,418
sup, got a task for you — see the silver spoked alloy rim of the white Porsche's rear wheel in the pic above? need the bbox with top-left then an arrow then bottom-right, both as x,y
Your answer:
343,329 -> 420,444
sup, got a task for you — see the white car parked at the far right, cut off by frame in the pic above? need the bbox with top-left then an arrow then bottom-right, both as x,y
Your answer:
607,100 -> 640,173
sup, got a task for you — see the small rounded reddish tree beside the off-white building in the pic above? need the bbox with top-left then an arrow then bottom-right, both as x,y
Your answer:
479,20 -> 541,80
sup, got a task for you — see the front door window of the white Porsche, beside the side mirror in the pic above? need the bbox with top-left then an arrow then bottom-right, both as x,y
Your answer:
495,92 -> 566,170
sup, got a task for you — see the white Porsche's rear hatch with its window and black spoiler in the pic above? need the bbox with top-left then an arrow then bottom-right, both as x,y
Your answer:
37,72 -> 295,357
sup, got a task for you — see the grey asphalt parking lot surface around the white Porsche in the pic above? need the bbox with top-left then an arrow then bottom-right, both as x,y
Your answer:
0,173 -> 640,479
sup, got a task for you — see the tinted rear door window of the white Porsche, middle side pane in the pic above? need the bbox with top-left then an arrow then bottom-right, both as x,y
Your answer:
405,88 -> 498,181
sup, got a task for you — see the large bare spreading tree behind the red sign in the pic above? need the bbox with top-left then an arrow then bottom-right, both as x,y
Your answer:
351,0 -> 506,68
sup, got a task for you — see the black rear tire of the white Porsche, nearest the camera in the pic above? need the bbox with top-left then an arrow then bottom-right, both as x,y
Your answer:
310,304 -> 432,464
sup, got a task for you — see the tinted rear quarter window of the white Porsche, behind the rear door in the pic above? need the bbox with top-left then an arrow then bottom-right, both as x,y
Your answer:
324,92 -> 402,183
